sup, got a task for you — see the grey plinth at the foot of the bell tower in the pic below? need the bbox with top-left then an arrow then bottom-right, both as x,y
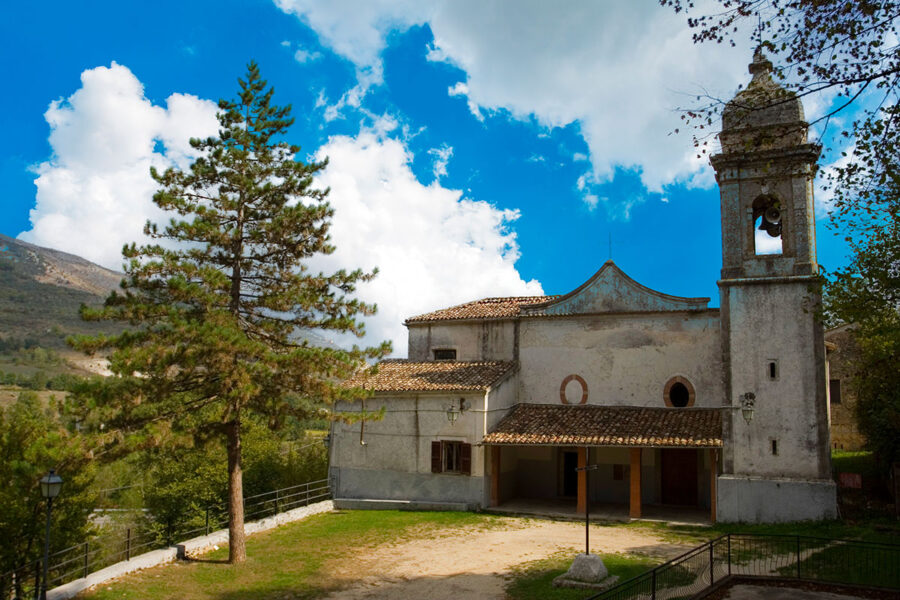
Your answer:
716,475 -> 838,523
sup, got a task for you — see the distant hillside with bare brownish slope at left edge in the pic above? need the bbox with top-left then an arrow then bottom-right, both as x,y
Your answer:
0,234 -> 123,350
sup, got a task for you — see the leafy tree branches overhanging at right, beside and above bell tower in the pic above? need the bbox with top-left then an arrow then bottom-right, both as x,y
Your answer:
660,0 -> 900,464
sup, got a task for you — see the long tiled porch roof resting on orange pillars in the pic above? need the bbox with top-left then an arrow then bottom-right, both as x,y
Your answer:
484,404 -> 722,448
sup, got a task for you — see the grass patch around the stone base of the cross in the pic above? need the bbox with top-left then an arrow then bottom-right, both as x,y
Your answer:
506,552 -> 661,600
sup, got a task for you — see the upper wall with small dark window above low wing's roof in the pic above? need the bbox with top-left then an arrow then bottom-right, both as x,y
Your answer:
409,320 -> 516,360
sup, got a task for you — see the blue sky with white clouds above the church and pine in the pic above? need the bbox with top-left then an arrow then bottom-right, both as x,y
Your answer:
0,0 -> 846,355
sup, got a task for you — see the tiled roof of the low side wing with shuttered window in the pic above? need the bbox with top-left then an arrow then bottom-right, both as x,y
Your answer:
344,360 -> 516,392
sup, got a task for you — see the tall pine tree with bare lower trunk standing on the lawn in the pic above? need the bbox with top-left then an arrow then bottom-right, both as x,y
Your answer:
74,63 -> 390,563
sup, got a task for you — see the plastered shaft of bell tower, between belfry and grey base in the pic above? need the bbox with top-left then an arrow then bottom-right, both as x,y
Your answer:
722,280 -> 831,479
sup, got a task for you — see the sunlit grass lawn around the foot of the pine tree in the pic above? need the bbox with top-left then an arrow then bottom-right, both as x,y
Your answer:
79,511 -> 502,600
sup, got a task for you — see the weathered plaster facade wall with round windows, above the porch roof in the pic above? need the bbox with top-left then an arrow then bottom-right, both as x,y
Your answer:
519,310 -> 724,407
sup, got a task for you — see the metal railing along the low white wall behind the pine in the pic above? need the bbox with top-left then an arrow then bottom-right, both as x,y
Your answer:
0,479 -> 331,600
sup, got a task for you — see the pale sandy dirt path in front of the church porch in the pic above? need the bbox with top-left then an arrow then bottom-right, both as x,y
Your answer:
329,519 -> 685,600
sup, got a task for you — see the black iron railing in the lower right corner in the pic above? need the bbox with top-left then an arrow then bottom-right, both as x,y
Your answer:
586,533 -> 900,600
